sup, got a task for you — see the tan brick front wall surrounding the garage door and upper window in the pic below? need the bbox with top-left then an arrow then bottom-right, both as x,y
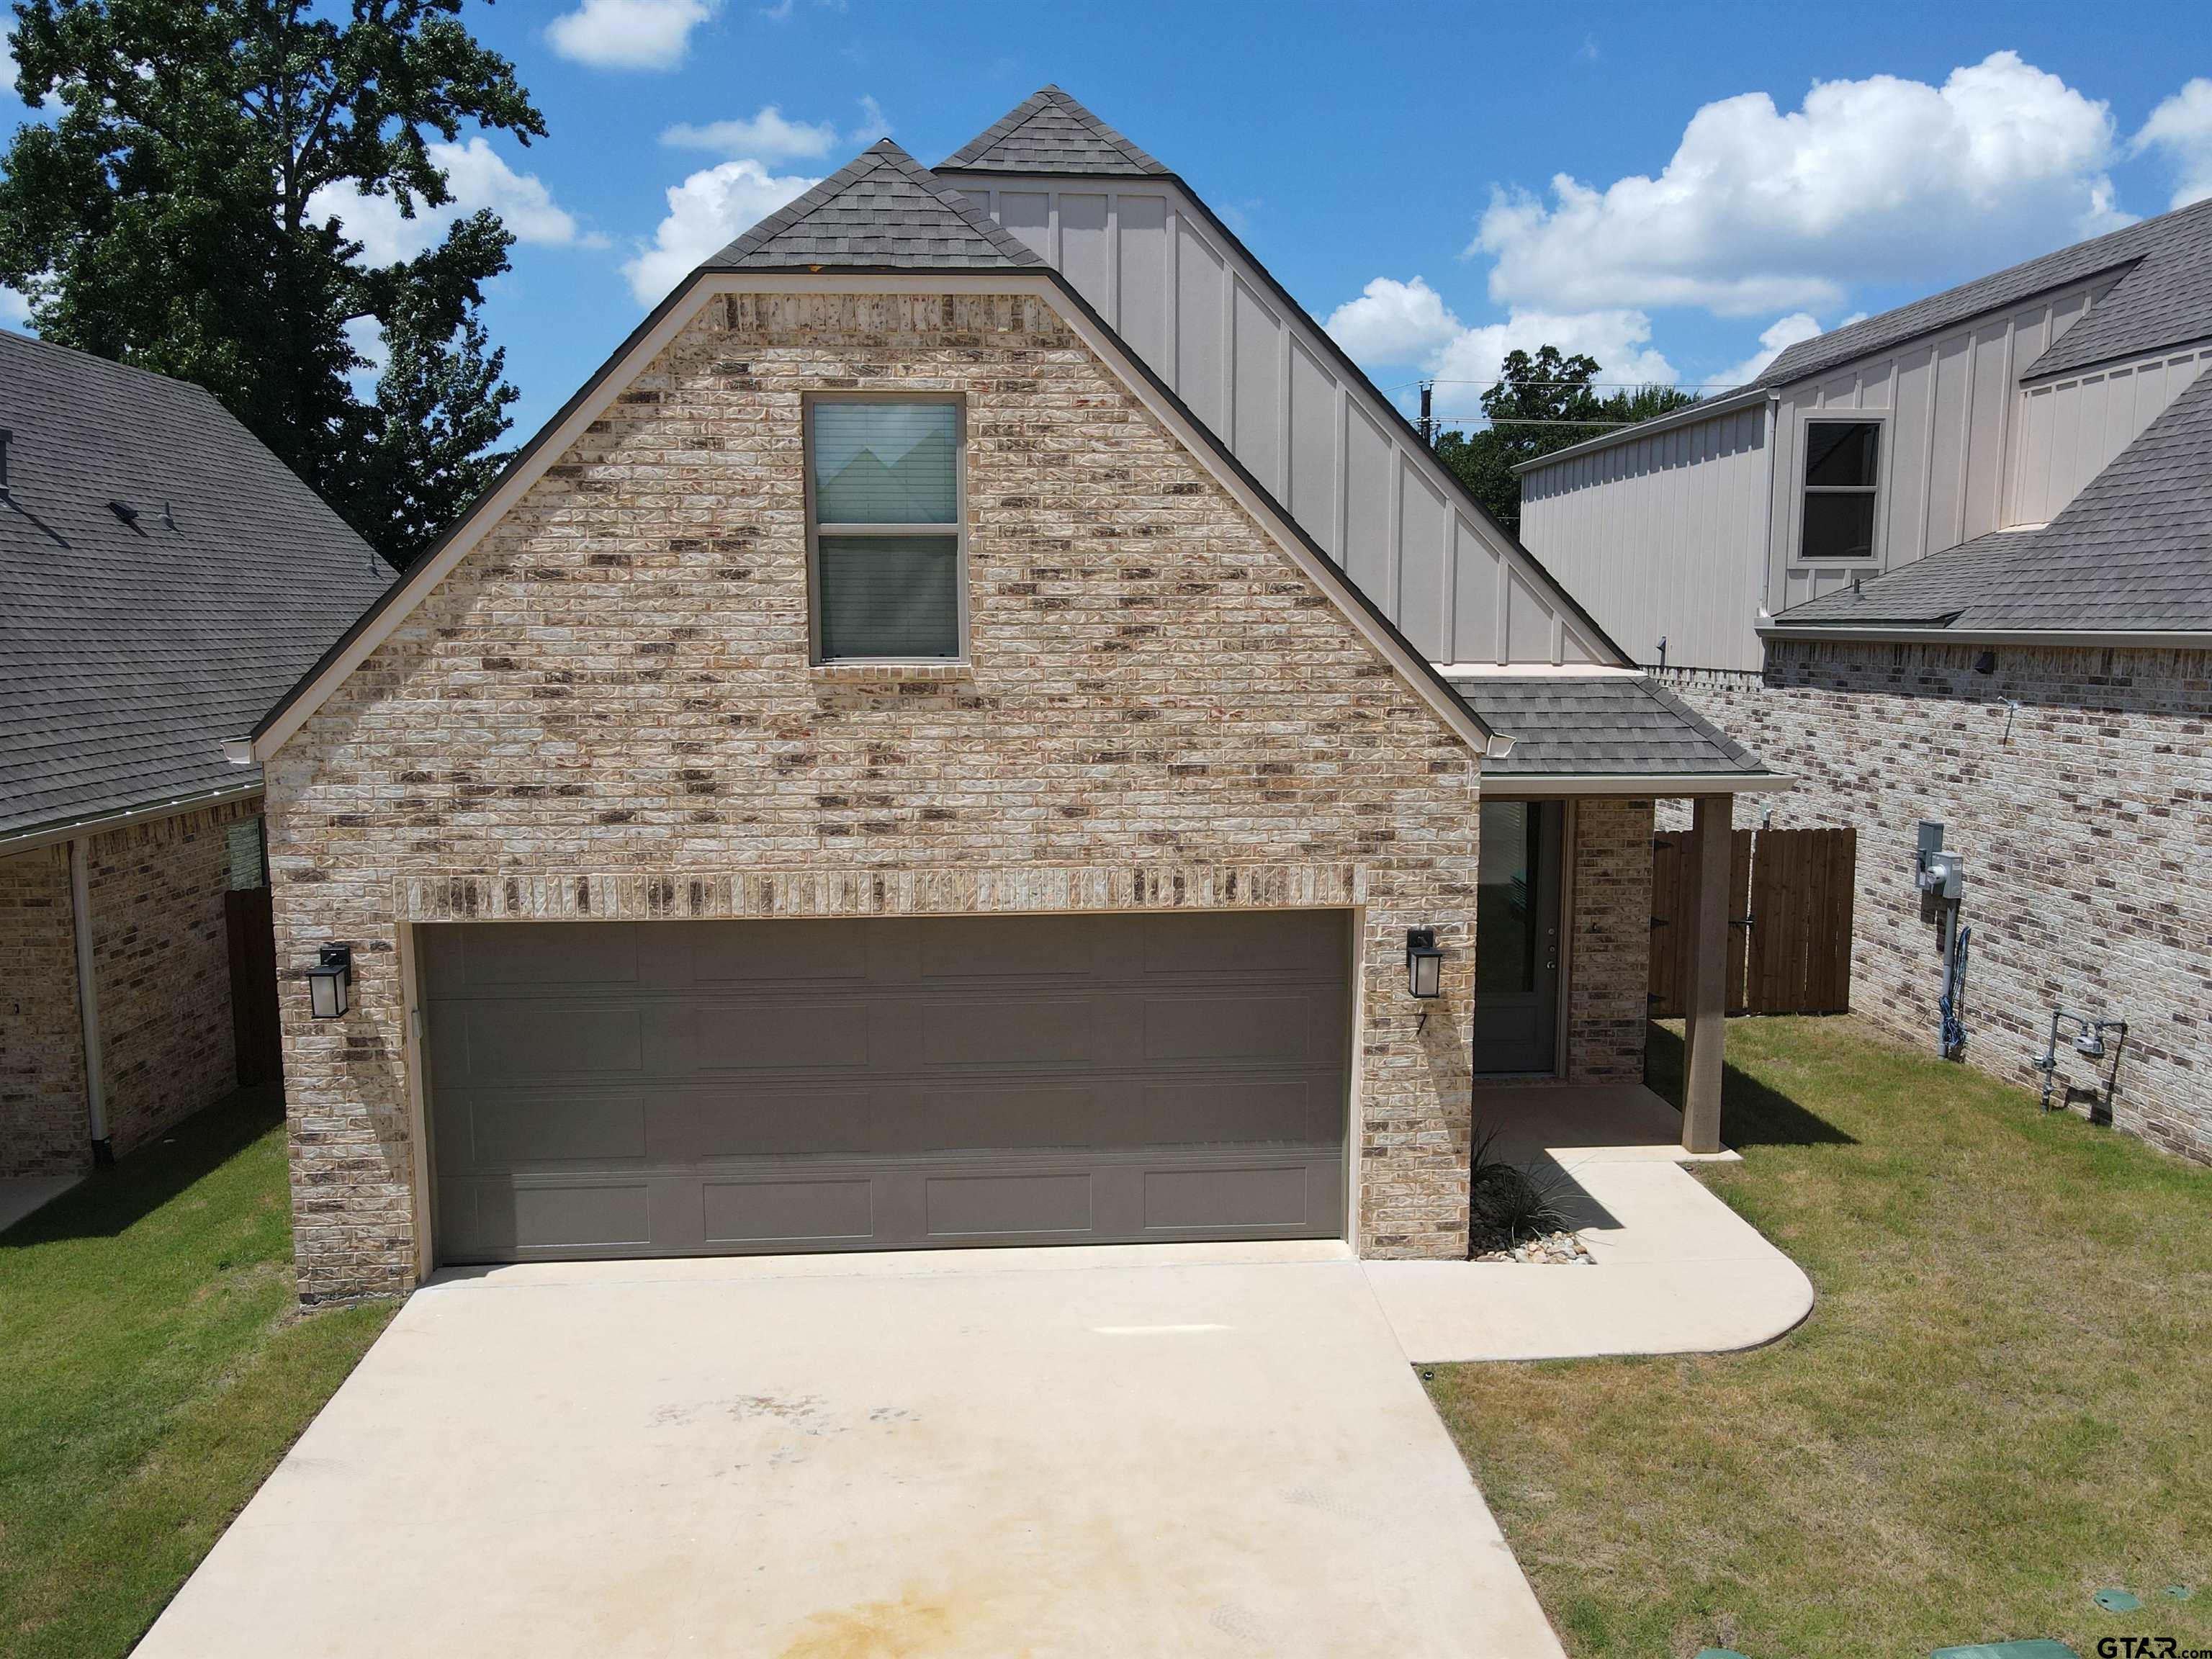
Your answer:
268,297 -> 1480,1298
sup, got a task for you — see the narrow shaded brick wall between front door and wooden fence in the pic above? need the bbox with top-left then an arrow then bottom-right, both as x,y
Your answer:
1566,801 -> 1653,1084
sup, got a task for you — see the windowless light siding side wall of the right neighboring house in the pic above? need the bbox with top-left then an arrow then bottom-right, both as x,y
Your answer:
1522,398 -> 1768,670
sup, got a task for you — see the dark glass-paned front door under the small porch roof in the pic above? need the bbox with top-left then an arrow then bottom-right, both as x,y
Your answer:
1475,801 -> 1564,1071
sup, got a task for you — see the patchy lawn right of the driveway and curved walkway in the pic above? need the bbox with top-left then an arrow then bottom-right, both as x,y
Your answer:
1429,1020 -> 2212,1659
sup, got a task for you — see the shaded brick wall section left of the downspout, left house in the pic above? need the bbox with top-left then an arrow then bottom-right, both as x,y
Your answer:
0,845 -> 93,1177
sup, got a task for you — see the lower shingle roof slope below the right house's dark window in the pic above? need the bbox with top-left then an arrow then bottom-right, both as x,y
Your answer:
1776,372 -> 2212,635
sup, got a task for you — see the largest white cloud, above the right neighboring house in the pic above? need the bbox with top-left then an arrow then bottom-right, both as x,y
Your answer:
1467,51 -> 2126,316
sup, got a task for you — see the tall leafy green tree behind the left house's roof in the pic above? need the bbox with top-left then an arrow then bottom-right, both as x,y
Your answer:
0,0 -> 544,566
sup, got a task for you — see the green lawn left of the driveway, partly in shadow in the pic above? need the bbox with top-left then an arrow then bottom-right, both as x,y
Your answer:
0,1097 -> 394,1659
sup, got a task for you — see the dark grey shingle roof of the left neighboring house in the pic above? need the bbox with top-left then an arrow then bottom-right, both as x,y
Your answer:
0,332 -> 392,836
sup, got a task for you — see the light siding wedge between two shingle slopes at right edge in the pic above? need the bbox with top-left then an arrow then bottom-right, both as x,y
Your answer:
2004,345 -> 2212,524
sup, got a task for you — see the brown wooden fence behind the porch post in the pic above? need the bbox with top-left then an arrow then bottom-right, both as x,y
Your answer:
1650,830 -> 1858,1020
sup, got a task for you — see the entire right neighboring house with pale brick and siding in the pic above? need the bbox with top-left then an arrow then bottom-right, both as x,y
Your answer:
1522,202 -> 2212,1159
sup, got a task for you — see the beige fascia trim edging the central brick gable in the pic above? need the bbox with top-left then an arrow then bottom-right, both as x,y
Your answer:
254,270 -> 1491,765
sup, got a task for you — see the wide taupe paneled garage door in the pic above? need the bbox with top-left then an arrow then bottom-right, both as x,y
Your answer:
421,912 -> 1352,1261
